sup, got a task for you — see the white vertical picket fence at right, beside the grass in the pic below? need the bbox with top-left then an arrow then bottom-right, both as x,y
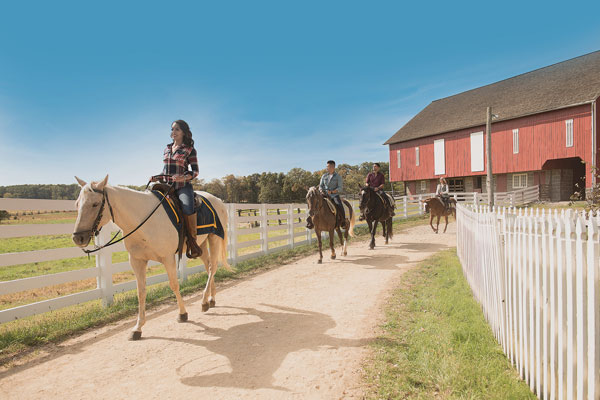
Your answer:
457,205 -> 600,400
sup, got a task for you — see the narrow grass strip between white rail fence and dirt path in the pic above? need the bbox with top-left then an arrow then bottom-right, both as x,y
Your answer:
0,218 -> 426,365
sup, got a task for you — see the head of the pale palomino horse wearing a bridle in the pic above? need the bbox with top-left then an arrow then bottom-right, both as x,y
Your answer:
72,175 -> 110,247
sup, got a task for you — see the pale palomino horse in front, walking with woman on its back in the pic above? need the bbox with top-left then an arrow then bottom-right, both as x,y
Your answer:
73,175 -> 231,340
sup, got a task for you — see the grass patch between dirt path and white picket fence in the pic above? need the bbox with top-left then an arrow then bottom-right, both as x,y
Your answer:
365,250 -> 535,399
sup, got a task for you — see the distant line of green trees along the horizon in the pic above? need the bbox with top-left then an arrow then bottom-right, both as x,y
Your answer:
0,162 -> 399,203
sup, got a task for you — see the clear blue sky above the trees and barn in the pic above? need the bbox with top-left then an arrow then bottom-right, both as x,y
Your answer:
0,1 -> 600,185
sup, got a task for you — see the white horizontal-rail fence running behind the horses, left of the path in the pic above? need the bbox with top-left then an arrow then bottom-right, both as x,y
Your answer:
0,188 -> 540,323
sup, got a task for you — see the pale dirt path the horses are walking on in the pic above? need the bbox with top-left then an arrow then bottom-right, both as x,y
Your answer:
0,223 -> 456,400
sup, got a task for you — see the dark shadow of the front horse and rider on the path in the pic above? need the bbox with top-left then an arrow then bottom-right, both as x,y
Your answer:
145,304 -> 370,391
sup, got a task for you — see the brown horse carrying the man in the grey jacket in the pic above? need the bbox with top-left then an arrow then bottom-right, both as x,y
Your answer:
306,186 -> 356,264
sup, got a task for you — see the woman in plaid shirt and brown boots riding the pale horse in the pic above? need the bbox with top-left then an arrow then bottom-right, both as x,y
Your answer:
150,119 -> 202,258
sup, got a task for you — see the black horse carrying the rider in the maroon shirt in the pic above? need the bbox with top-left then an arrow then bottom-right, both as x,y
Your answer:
358,186 -> 396,250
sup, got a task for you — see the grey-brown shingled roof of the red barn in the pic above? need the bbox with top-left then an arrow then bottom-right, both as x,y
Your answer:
385,51 -> 600,144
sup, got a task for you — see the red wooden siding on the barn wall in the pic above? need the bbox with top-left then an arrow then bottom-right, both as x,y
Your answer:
390,104 -> 600,186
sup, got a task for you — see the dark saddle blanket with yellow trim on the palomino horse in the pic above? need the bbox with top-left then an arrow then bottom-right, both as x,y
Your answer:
152,191 -> 225,239
